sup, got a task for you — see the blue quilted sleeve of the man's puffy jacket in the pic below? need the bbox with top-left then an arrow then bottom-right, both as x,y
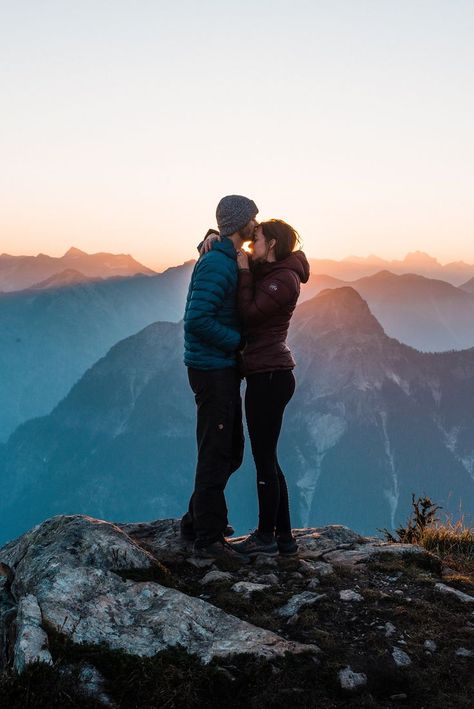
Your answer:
184,251 -> 240,352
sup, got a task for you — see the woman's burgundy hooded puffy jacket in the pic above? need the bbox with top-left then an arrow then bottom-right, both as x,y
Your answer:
237,251 -> 309,375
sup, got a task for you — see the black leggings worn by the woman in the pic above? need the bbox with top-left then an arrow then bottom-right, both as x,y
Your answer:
245,369 -> 295,534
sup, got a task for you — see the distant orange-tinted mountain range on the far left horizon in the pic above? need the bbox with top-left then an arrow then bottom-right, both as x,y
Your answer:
0,246 -> 156,292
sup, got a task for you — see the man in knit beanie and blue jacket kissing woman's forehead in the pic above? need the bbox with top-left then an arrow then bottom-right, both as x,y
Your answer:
181,195 -> 258,562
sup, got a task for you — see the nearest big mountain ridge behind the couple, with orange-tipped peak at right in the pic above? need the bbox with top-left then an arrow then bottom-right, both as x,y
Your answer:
0,287 -> 474,541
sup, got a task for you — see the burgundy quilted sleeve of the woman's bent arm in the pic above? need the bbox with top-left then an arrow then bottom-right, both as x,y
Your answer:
238,269 -> 300,327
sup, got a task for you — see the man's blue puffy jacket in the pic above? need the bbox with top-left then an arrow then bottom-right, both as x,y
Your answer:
184,238 -> 241,369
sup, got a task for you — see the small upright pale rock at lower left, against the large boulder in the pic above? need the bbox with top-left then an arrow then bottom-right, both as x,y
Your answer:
13,594 -> 53,672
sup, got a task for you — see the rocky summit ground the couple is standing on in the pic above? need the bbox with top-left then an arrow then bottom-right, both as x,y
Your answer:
0,515 -> 474,707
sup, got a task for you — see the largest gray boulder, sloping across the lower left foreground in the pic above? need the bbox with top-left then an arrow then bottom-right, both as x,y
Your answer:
0,515 -> 317,667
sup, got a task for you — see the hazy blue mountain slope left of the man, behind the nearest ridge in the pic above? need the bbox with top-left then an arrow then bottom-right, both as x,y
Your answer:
0,262 -> 192,441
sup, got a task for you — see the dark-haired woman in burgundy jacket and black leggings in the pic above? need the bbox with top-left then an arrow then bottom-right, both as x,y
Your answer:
232,219 -> 309,556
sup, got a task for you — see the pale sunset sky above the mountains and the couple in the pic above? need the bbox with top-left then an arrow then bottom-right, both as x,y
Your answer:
0,0 -> 474,270
